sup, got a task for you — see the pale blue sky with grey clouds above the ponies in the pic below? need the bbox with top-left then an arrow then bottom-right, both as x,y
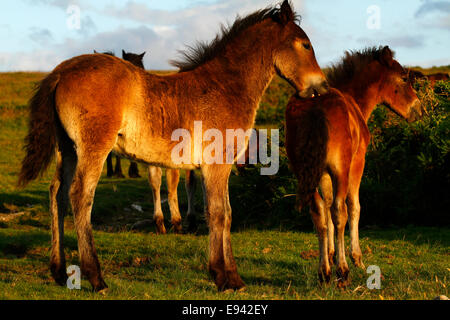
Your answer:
0,0 -> 450,72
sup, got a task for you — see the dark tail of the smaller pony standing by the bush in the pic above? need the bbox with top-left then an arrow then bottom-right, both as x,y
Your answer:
294,107 -> 329,210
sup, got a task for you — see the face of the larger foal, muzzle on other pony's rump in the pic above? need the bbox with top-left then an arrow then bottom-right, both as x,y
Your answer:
274,1 -> 328,98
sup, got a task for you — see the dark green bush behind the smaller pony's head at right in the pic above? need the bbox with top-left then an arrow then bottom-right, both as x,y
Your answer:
360,82 -> 450,225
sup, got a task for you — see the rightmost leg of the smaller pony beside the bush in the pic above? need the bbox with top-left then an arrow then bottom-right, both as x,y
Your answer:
347,152 -> 365,269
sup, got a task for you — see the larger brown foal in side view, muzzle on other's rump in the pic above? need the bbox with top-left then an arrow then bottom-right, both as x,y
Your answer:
19,0 -> 328,291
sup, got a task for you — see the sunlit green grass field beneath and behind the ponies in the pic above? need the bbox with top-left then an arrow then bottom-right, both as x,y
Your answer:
0,73 -> 450,300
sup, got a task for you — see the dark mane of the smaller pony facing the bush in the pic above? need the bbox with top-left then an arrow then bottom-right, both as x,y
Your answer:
326,47 -> 394,87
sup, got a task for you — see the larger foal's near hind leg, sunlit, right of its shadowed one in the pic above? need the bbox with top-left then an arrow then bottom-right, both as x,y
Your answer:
70,149 -> 108,292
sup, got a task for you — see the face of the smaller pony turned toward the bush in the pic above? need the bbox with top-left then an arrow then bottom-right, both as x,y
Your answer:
378,47 -> 422,122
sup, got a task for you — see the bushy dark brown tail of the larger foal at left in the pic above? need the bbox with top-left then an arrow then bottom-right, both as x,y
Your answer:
18,74 -> 59,188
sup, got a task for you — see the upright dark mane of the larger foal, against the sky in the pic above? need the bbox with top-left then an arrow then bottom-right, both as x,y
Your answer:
170,3 -> 300,72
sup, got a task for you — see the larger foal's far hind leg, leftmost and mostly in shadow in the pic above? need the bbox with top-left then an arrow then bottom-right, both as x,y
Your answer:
50,139 -> 77,286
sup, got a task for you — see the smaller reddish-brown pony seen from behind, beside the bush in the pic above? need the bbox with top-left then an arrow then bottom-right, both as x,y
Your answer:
286,47 -> 421,286
